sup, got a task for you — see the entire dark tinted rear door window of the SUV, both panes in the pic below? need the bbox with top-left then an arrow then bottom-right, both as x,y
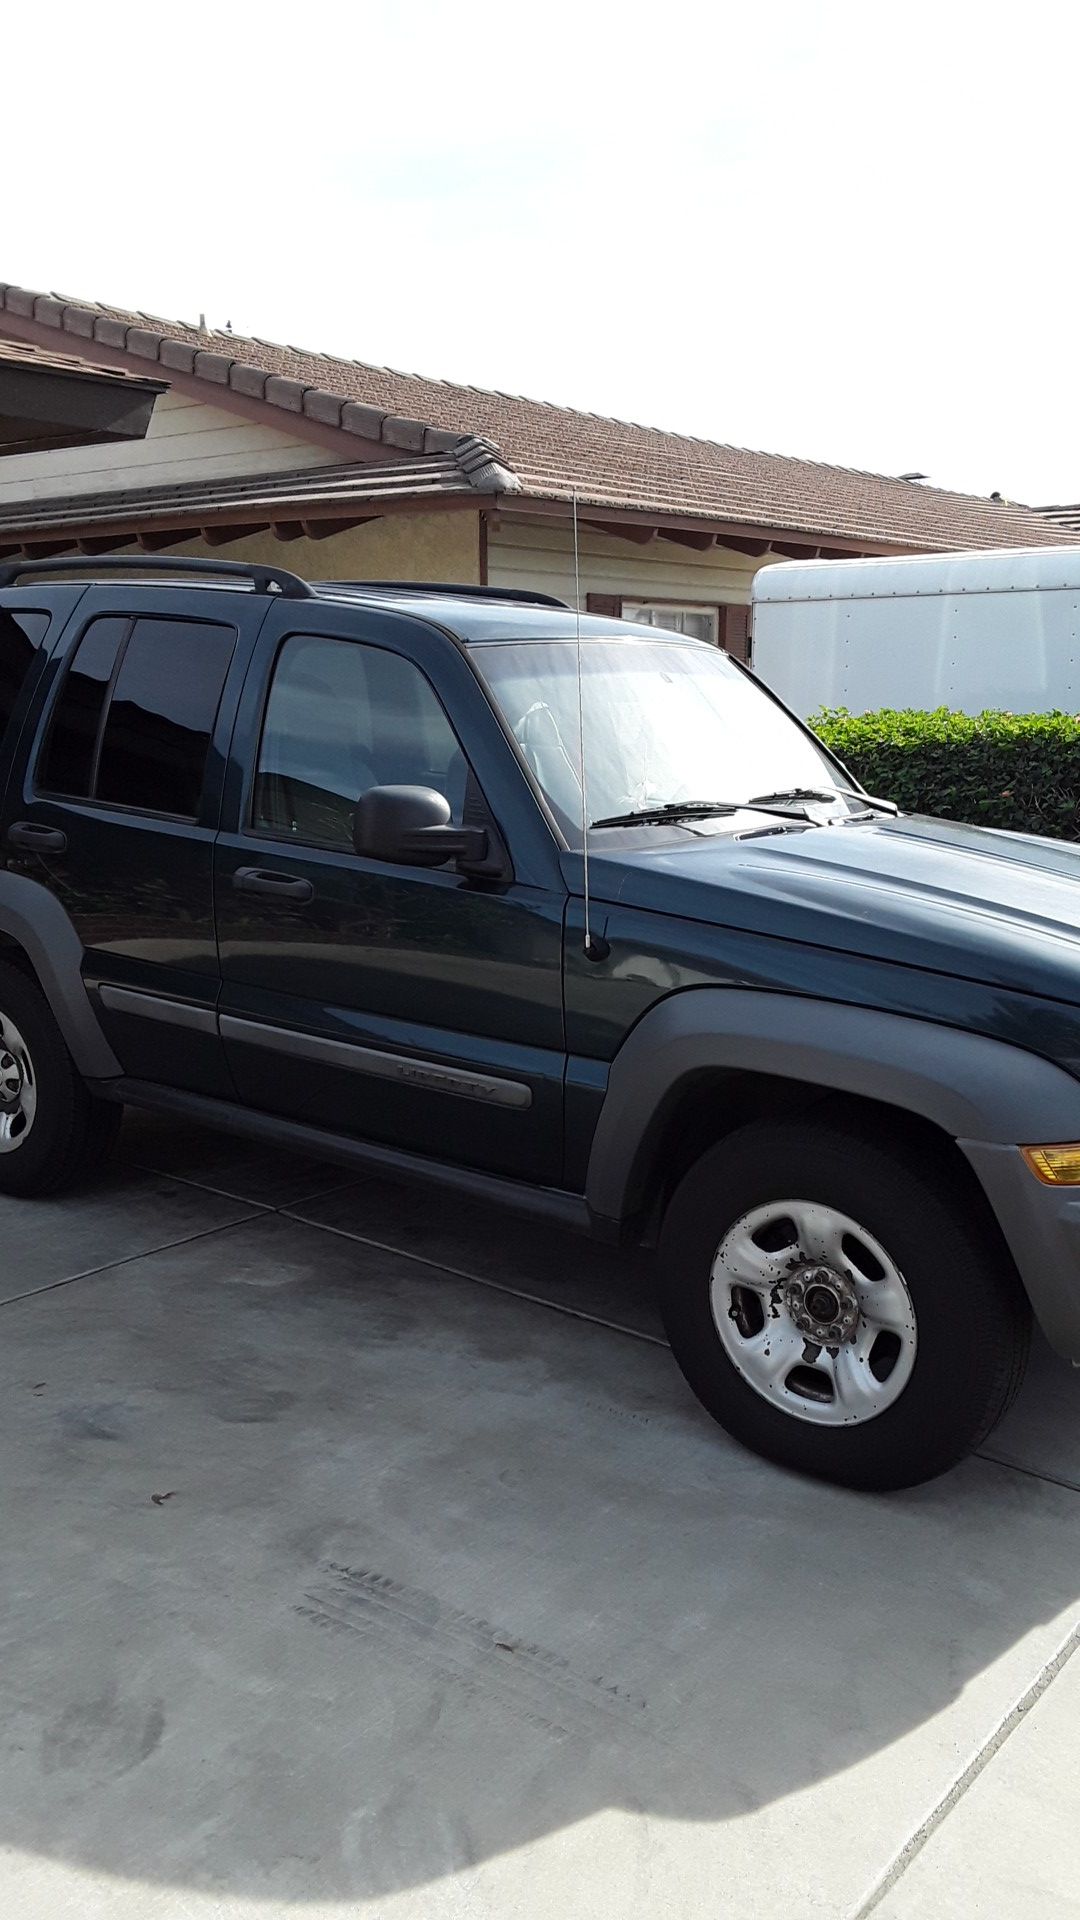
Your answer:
40,614 -> 236,820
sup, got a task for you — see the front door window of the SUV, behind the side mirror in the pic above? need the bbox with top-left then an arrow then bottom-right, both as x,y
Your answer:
254,634 -> 467,849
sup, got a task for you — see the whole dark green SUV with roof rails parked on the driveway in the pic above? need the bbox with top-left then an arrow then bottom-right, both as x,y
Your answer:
0,561 -> 1080,1488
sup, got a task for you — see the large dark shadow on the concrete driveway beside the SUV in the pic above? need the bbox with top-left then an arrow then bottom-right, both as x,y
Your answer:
0,1144 -> 1080,1903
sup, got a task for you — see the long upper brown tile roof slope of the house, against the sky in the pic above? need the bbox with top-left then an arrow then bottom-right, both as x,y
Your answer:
0,284 -> 1072,551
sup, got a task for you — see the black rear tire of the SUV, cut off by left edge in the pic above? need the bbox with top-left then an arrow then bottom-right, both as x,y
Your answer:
0,962 -> 123,1196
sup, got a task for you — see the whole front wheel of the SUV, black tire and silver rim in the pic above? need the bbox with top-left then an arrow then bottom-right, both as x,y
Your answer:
659,1123 -> 1030,1490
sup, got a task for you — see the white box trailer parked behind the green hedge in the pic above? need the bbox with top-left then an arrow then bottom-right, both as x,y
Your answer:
751,545 -> 1080,718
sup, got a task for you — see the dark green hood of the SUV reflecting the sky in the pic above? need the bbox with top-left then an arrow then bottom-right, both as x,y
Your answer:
590,816 -> 1080,1004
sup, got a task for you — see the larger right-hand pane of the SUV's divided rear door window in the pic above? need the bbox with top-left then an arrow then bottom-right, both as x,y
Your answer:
94,620 -> 236,816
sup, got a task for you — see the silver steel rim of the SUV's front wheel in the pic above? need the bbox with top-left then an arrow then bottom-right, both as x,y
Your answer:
711,1200 -> 919,1427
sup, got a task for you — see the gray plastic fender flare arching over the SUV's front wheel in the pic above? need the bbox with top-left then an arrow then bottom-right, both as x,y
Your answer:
586,987 -> 1080,1221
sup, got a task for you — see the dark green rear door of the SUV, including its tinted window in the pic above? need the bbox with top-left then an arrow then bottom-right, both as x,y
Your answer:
6,586 -> 267,1096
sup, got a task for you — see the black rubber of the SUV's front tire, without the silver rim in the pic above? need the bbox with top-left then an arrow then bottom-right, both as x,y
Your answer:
659,1123 -> 1030,1492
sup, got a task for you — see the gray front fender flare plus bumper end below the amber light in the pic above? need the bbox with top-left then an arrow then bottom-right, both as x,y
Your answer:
586,987 -> 1080,1363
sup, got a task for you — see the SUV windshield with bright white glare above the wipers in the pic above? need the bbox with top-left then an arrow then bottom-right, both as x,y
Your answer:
473,637 -> 847,847
